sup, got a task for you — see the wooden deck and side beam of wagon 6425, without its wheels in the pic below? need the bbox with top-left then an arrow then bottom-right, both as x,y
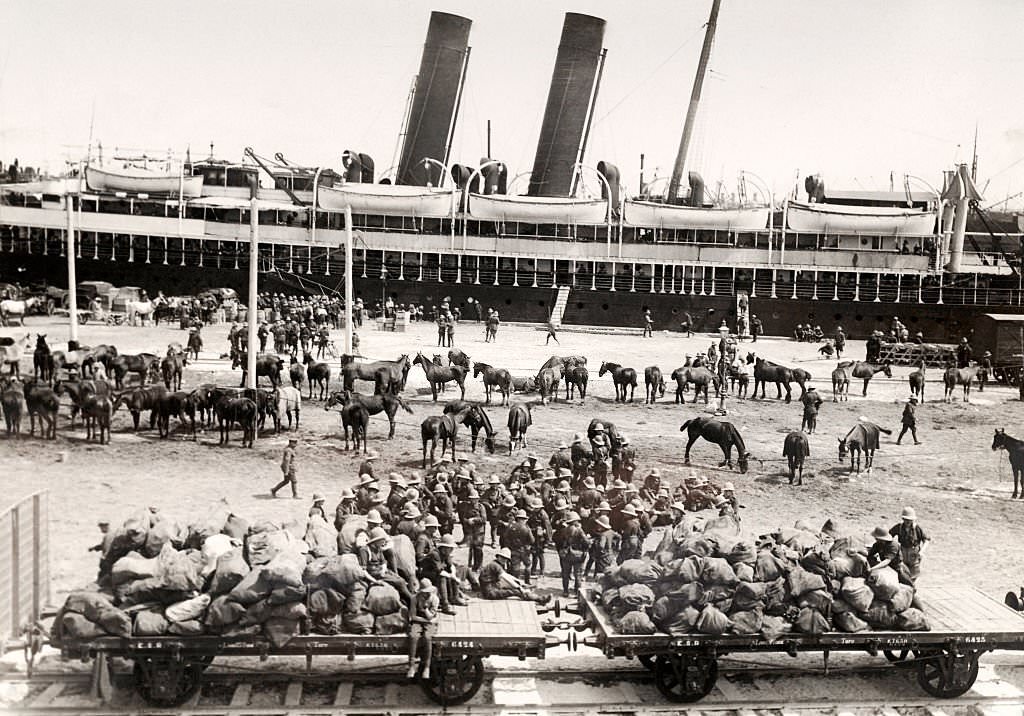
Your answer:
583,587 -> 1024,657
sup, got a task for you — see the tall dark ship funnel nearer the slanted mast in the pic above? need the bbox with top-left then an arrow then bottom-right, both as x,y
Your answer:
528,12 -> 605,197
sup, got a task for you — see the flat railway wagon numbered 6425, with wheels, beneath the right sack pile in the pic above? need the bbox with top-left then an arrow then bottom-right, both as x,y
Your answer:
580,587 -> 1024,703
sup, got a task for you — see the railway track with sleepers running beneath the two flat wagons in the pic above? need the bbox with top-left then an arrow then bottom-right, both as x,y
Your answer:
0,660 -> 1024,716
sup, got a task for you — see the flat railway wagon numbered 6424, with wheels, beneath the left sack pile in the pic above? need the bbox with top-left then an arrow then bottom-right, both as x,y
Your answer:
54,599 -> 560,708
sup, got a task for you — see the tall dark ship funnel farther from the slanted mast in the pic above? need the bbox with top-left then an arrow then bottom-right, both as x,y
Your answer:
395,11 -> 473,186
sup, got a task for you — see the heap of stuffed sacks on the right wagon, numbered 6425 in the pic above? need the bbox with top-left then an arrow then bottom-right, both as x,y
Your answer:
601,522 -> 929,641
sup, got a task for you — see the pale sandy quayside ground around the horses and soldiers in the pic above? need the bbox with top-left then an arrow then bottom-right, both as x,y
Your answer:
0,317 -> 1024,601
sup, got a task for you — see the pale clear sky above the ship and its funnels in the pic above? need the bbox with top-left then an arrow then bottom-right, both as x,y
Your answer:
0,0 -> 1024,209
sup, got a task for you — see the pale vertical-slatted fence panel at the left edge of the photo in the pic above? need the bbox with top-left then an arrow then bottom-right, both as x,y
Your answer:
0,491 -> 50,652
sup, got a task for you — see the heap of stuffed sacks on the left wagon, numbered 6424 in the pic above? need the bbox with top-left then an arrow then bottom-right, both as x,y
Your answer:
52,507 -> 416,646
